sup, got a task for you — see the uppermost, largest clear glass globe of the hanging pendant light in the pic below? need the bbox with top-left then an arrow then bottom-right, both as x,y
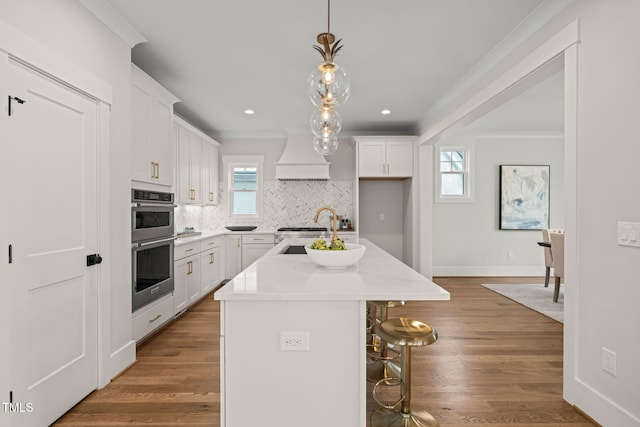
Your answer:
307,61 -> 351,107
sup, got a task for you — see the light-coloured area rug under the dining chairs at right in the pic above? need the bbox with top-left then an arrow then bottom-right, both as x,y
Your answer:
482,283 -> 564,323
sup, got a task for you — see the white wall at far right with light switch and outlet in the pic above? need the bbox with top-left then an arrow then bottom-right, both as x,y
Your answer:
423,0 -> 640,427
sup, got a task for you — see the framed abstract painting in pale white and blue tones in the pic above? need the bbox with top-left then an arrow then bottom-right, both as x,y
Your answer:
500,165 -> 549,230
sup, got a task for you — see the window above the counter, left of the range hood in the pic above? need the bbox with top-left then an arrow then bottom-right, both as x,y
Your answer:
222,156 -> 263,220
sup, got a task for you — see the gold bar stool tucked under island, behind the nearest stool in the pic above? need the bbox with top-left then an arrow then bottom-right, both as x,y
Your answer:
367,301 -> 405,382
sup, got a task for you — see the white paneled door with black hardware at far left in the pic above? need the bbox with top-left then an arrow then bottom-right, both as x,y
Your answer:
1,58 -> 100,426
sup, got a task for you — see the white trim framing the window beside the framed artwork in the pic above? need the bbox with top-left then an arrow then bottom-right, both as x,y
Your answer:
433,142 -> 475,203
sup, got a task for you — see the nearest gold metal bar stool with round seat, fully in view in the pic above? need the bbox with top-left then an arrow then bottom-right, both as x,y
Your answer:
371,318 -> 440,427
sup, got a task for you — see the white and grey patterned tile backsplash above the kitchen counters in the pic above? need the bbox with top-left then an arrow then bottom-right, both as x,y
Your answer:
175,181 -> 353,231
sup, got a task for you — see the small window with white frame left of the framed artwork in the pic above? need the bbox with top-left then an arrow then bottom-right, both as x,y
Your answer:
435,145 -> 473,202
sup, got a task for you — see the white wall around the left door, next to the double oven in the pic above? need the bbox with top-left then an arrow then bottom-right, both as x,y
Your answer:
0,0 -> 135,383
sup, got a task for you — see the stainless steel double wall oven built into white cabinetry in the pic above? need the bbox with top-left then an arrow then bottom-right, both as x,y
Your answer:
131,189 -> 176,311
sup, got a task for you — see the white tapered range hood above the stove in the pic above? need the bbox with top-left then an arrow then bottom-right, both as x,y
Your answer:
275,134 -> 330,181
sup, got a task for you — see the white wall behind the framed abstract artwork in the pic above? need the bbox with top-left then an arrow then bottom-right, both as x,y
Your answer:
433,137 -> 564,276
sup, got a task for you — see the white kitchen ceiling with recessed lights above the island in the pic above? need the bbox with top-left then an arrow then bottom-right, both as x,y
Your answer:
89,0 -> 560,139
